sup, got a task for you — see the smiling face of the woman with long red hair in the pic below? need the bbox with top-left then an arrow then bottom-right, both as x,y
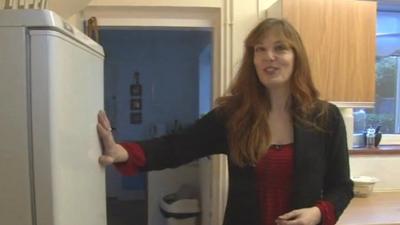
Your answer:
254,35 -> 295,88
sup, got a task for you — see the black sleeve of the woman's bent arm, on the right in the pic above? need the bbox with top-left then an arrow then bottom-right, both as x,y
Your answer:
323,105 -> 353,219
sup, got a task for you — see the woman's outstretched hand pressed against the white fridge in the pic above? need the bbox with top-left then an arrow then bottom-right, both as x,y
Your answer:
97,111 -> 129,166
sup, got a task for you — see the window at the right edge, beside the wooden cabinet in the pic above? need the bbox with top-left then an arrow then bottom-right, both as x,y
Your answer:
353,11 -> 400,144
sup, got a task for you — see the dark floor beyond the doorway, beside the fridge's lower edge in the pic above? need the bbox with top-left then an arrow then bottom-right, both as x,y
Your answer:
107,198 -> 147,225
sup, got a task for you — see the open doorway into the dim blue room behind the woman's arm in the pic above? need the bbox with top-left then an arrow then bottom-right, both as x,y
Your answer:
100,27 -> 213,225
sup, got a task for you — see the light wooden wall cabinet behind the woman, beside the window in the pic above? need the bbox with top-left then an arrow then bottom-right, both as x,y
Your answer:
267,0 -> 377,105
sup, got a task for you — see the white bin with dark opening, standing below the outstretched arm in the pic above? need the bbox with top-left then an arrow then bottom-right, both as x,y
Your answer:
160,188 -> 200,225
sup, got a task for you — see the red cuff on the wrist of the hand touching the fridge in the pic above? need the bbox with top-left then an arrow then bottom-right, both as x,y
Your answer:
114,142 -> 146,176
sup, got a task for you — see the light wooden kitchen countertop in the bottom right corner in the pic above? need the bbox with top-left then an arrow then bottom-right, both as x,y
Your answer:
337,192 -> 400,225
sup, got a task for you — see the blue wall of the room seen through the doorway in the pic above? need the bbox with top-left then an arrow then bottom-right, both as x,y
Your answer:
100,29 -> 211,190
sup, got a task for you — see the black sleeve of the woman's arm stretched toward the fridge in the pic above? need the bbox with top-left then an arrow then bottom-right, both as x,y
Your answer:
138,110 -> 227,171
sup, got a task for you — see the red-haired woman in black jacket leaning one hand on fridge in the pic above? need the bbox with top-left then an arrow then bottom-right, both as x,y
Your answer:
98,19 -> 353,225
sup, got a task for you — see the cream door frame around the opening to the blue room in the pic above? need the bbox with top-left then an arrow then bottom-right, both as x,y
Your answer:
82,5 -> 228,225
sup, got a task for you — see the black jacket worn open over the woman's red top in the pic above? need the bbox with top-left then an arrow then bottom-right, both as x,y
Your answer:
139,104 -> 353,225
